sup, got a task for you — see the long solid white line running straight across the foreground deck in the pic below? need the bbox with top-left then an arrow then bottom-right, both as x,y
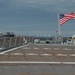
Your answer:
0,61 -> 75,65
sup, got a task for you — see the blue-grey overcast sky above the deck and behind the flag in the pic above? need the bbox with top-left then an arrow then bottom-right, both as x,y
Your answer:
0,0 -> 75,36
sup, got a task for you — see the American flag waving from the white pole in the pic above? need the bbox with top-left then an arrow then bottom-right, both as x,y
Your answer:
59,12 -> 75,25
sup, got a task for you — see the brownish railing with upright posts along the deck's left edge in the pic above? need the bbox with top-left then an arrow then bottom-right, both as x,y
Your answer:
0,36 -> 24,51
